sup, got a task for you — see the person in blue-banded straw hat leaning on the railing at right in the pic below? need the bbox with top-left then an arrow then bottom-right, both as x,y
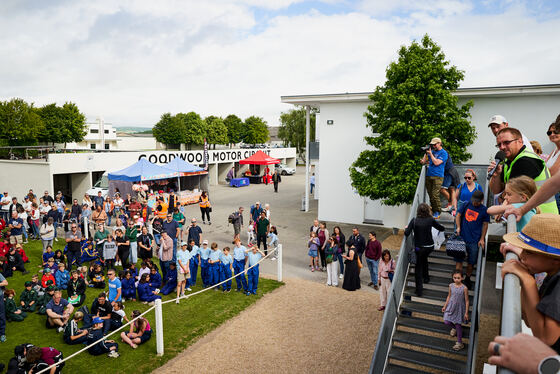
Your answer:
500,213 -> 560,353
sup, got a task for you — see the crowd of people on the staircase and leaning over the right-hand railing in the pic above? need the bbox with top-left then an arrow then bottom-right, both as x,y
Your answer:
412,115 -> 560,373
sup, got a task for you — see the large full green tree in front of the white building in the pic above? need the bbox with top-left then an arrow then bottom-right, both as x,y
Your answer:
350,35 -> 476,205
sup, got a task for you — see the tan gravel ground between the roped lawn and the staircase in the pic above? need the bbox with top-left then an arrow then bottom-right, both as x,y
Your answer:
156,279 -> 383,374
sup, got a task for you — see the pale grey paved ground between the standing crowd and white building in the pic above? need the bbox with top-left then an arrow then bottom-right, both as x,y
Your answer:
178,167 -> 391,285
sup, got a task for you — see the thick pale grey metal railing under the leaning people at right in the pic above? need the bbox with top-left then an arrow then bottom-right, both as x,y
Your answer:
498,214 -> 521,374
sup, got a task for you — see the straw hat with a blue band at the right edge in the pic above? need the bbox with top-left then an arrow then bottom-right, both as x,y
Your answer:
504,213 -> 560,259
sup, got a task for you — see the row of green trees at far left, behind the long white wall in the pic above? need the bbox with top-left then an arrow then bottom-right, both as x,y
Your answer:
0,98 -> 87,145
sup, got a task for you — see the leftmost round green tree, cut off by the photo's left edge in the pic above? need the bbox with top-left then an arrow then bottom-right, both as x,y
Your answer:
0,98 -> 45,145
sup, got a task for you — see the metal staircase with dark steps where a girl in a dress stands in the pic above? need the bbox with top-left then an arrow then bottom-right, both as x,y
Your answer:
369,165 -> 487,374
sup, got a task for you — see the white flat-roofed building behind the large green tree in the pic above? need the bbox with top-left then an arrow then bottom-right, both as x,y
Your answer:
281,85 -> 560,227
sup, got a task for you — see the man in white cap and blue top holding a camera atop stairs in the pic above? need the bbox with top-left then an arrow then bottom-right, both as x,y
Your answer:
420,138 -> 449,219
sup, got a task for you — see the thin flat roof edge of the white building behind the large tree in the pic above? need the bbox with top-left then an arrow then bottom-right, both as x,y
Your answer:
280,84 -> 560,106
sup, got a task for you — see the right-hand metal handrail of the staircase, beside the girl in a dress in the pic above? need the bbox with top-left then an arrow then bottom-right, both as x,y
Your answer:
466,183 -> 488,374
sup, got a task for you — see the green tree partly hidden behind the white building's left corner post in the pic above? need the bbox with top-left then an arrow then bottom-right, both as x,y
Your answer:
278,107 -> 316,161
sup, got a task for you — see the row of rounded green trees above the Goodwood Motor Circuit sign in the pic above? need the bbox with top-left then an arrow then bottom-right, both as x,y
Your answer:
152,112 -> 269,149
